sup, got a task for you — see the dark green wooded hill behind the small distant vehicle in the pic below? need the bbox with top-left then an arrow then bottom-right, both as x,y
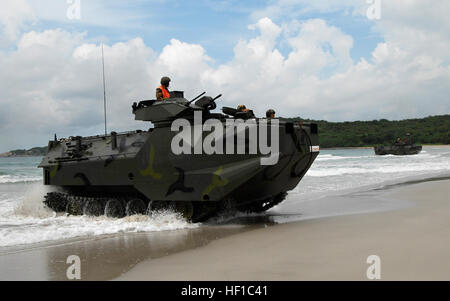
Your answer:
287,115 -> 450,147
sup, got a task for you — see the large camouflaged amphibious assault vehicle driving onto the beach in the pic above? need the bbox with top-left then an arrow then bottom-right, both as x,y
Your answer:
39,91 -> 319,222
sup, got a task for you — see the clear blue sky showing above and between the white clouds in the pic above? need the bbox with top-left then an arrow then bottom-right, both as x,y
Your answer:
25,0 -> 383,63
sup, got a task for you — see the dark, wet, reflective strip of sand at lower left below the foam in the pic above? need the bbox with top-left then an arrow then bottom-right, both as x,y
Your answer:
0,225 -> 259,281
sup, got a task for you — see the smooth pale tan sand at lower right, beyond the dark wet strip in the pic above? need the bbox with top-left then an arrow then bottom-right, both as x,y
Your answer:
117,180 -> 450,280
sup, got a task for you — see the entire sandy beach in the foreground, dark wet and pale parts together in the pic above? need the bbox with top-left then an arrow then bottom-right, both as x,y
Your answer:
0,180 -> 450,280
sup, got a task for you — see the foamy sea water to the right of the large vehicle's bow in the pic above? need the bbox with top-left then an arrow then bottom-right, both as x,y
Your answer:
291,146 -> 450,200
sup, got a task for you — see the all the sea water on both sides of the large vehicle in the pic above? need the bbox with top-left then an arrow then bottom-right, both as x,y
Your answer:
0,146 -> 450,247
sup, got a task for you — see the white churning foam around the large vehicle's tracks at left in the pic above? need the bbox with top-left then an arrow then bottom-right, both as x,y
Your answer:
0,182 -> 199,248
